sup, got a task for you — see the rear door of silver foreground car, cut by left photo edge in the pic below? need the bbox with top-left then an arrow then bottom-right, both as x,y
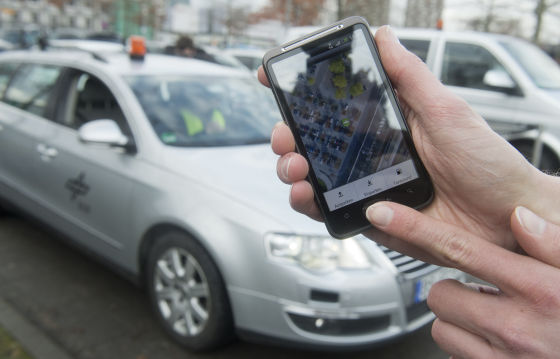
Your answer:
0,64 -> 61,213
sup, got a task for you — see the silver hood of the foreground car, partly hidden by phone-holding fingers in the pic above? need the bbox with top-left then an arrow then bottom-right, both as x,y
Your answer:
163,144 -> 328,234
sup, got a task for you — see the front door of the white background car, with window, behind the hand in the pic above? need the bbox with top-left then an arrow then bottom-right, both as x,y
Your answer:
436,40 -> 522,132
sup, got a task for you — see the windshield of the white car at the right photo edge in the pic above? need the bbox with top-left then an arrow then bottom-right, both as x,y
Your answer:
500,41 -> 560,90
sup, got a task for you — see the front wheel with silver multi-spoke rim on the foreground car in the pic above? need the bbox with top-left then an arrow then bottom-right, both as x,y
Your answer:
146,231 -> 233,351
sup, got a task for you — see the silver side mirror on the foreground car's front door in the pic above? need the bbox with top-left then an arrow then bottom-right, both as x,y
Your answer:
78,119 -> 135,152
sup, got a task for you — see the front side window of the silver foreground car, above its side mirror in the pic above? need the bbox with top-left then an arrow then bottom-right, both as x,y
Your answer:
62,70 -> 130,134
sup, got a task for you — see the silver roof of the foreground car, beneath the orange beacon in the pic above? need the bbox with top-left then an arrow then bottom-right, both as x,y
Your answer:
0,50 -> 252,77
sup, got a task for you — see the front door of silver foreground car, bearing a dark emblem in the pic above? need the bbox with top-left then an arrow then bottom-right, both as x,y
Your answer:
33,69 -> 136,256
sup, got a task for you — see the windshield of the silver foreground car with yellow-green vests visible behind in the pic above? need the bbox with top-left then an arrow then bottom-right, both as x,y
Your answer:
126,75 -> 280,146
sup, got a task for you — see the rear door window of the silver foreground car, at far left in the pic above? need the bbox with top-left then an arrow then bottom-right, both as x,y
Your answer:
4,64 -> 61,116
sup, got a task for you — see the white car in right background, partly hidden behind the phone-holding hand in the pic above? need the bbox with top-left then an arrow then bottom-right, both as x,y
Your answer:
397,29 -> 560,171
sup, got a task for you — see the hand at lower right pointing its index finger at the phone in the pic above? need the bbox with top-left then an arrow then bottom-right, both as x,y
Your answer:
367,202 -> 560,359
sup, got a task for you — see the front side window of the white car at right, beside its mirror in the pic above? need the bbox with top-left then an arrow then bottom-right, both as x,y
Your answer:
441,42 -> 508,90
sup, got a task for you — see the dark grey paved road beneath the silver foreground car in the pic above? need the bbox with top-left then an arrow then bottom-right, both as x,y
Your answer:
0,216 -> 448,359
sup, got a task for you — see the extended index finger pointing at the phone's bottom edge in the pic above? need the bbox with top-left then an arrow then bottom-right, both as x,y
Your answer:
366,202 -> 544,293
